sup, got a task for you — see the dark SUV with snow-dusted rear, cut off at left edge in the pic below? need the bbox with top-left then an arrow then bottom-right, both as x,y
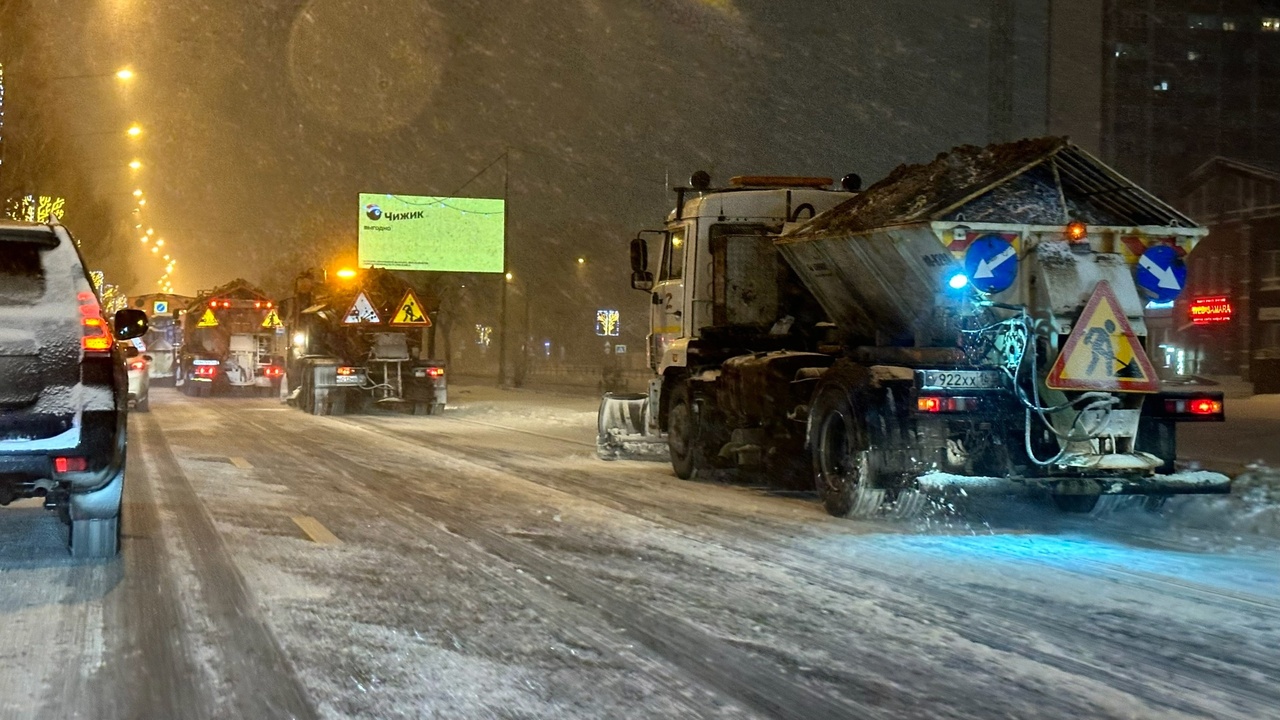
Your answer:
0,220 -> 147,557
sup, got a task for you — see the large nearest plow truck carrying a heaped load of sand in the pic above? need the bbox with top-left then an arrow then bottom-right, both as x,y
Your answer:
598,138 -> 1230,516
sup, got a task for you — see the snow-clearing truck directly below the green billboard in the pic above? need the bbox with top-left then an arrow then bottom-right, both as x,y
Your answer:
284,268 -> 447,415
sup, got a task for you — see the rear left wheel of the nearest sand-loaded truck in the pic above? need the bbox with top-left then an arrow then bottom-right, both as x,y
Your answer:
809,368 -> 884,518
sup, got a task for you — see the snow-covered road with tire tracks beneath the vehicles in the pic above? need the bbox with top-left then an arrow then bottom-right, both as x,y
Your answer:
0,387 -> 1280,720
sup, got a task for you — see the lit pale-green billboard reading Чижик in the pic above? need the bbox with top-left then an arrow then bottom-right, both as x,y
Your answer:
358,192 -> 506,273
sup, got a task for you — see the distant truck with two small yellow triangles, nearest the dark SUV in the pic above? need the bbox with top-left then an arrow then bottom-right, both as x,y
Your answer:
175,279 -> 284,397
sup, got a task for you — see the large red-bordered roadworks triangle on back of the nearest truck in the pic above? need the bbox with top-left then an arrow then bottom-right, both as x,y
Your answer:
1044,281 -> 1160,392
